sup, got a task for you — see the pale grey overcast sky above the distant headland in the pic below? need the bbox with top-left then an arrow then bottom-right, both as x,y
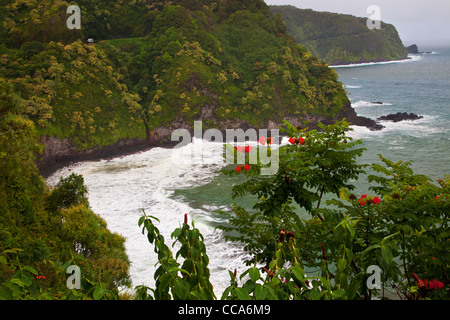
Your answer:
265,0 -> 450,50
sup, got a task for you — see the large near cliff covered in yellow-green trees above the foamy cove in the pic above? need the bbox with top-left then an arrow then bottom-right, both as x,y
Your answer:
0,0 -> 376,176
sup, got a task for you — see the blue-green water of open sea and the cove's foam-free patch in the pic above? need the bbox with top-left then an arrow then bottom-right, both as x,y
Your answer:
173,48 -> 450,223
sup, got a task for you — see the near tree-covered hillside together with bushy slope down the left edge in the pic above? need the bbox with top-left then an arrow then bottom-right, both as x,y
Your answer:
0,0 -> 356,298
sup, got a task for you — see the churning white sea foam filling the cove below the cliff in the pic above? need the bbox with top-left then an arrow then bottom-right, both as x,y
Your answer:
48,140 -> 253,298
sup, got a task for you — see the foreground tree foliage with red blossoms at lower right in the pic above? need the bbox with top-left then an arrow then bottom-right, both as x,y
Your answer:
219,122 -> 450,299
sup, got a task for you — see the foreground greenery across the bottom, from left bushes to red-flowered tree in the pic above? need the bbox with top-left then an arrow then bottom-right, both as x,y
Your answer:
0,117 -> 450,300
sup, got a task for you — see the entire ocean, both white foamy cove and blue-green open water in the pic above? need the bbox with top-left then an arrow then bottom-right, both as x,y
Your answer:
48,48 -> 450,298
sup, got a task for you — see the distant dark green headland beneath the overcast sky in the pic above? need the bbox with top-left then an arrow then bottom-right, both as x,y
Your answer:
270,6 -> 407,65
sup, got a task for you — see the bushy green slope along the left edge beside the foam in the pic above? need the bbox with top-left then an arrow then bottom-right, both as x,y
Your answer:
0,79 -> 130,299
